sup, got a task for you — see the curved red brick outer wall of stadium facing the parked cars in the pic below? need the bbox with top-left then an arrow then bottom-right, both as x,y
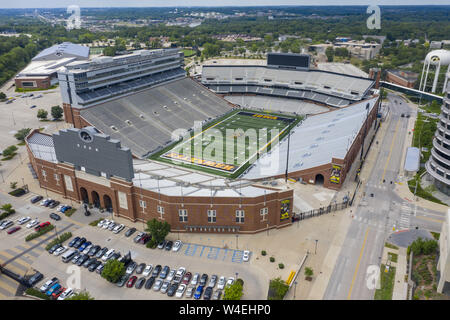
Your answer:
27,130 -> 293,233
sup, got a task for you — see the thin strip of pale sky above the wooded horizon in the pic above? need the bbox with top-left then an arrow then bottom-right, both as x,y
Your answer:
0,0 -> 450,8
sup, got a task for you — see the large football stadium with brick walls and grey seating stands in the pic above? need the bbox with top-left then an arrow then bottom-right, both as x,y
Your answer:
26,49 -> 379,233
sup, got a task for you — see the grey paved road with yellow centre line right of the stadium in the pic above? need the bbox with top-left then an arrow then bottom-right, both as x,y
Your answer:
323,93 -> 444,300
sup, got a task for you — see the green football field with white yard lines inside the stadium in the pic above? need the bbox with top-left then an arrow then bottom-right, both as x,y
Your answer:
156,110 -> 300,176
